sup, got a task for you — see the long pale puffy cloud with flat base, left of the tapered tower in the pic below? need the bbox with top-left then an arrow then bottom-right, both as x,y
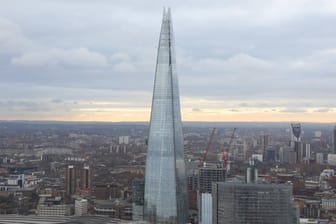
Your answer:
11,48 -> 108,67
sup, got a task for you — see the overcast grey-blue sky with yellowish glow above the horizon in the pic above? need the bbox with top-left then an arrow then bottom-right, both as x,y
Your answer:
0,0 -> 336,122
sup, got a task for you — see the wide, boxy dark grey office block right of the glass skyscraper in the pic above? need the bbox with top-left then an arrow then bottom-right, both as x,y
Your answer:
212,182 -> 297,224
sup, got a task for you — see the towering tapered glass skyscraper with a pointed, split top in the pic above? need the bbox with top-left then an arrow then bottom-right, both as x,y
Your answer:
144,9 -> 188,224
